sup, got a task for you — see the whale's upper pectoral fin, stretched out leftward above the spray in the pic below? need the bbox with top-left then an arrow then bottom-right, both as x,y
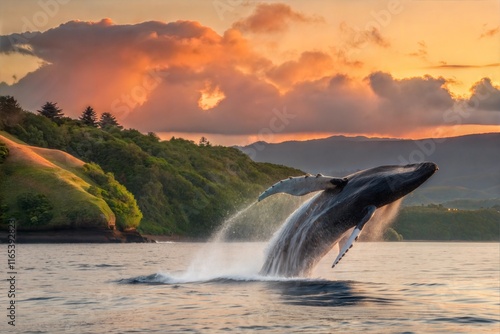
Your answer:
259,174 -> 347,201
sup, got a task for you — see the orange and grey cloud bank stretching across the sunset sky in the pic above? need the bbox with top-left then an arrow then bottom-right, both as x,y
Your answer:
0,5 -> 500,141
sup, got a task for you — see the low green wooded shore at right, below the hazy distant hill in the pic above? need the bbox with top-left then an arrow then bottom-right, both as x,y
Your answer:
392,204 -> 500,241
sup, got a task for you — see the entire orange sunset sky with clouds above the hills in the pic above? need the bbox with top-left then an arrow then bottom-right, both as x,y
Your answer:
0,0 -> 500,145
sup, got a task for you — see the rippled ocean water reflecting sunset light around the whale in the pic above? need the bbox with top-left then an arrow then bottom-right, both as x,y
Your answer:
4,242 -> 500,333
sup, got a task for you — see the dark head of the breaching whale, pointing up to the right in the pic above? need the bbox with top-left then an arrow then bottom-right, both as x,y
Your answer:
343,162 -> 438,208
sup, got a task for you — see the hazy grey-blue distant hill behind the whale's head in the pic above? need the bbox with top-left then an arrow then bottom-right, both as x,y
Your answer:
239,133 -> 500,205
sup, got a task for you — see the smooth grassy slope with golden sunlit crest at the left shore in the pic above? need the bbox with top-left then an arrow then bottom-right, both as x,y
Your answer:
0,133 -> 115,228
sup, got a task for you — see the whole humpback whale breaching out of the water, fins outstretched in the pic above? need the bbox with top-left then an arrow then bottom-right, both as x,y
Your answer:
259,162 -> 438,277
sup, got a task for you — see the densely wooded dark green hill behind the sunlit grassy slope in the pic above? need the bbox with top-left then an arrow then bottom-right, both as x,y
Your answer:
0,97 -> 303,236
